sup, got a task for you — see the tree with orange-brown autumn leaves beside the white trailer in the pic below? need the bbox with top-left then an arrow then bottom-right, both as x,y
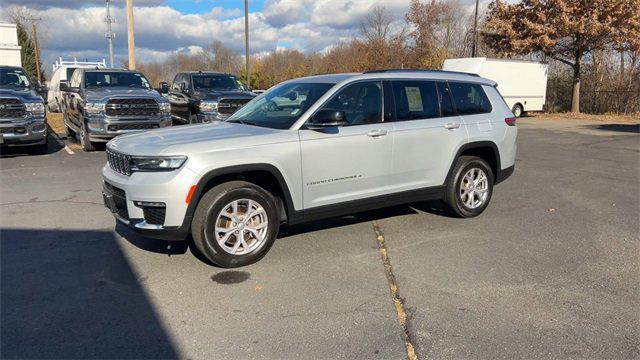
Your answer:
482,0 -> 640,113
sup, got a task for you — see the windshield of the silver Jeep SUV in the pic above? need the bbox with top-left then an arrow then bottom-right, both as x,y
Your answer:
227,83 -> 335,129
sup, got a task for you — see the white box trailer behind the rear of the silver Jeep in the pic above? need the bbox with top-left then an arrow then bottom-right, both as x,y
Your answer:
442,58 -> 549,117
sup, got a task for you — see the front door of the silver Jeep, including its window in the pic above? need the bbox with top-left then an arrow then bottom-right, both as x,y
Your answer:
300,81 -> 393,209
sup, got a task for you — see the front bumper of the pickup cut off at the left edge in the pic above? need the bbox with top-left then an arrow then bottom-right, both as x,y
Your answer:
0,116 -> 47,146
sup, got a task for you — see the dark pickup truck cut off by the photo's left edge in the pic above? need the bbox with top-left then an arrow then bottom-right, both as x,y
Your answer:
0,66 -> 47,147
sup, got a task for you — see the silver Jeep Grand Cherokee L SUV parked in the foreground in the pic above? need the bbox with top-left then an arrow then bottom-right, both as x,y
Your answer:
102,70 -> 517,267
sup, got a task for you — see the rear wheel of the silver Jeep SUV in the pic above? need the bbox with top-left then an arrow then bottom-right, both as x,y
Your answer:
445,156 -> 494,218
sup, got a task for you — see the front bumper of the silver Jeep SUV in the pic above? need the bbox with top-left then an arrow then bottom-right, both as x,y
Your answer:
102,165 -> 197,241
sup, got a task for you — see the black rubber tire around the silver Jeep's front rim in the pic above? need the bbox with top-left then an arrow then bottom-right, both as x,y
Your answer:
191,181 -> 280,268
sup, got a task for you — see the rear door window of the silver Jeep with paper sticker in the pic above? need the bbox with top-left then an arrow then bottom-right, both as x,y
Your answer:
393,81 -> 440,121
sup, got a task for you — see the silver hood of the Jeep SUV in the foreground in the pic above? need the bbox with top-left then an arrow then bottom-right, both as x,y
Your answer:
108,121 -> 288,156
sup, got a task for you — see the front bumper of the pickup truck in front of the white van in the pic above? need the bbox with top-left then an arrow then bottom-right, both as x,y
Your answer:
86,114 -> 171,141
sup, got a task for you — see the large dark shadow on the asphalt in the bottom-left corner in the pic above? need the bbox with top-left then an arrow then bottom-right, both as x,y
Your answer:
0,228 -> 178,358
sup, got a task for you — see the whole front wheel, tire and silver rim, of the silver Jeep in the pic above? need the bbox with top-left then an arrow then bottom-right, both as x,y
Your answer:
191,181 -> 280,268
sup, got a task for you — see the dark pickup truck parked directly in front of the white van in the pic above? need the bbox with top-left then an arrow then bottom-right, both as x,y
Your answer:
60,69 -> 171,151
